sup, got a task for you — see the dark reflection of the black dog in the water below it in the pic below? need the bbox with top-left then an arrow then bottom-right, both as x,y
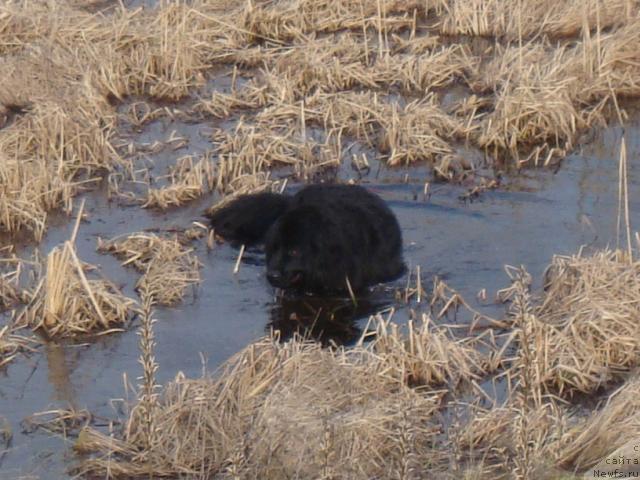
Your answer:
267,294 -> 390,346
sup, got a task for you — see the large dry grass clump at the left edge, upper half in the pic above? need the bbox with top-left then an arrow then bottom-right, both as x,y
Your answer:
0,61 -> 118,239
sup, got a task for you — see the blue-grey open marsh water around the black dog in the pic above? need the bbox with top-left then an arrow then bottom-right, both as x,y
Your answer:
0,110 -> 640,479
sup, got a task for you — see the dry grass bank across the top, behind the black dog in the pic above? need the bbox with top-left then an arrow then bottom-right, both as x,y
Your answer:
0,0 -> 640,239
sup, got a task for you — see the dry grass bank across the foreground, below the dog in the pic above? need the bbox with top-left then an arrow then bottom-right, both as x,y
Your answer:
30,251 -> 638,479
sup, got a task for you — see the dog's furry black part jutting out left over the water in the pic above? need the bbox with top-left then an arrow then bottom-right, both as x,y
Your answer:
205,193 -> 291,246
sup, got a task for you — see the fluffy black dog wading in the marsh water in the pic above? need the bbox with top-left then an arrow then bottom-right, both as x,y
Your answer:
209,185 -> 405,293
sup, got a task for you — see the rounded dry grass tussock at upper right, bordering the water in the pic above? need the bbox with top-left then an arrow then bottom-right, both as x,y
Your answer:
477,46 -> 595,165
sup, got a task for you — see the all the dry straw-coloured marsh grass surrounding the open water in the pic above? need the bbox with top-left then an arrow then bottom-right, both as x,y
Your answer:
0,0 -> 640,479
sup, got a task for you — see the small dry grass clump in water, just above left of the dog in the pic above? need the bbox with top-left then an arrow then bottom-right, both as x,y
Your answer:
143,155 -> 214,210
